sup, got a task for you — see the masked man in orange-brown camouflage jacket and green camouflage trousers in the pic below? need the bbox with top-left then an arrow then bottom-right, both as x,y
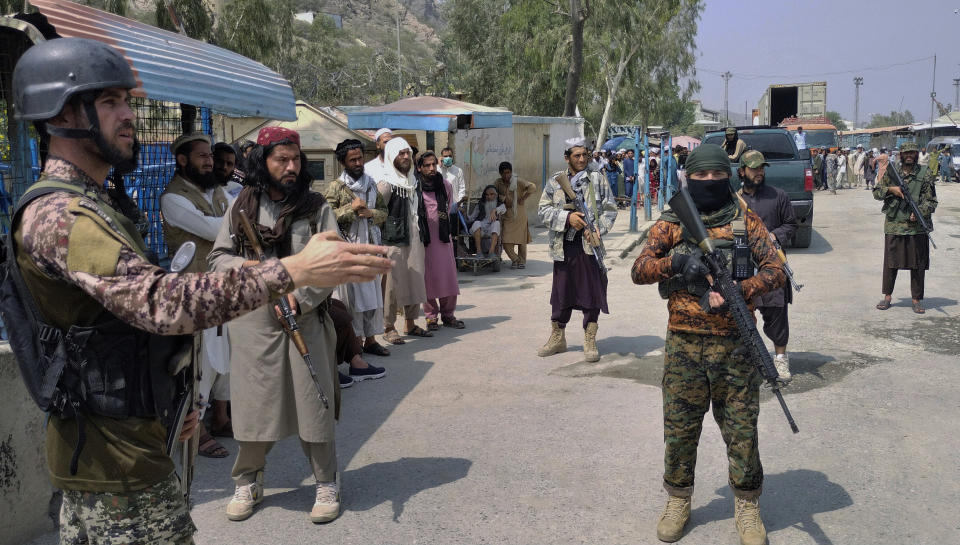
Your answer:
632,144 -> 786,544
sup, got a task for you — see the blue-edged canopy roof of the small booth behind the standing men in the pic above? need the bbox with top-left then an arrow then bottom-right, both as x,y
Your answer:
347,96 -> 513,131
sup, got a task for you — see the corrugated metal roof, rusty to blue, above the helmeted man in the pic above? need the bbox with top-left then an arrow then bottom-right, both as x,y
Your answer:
30,0 -> 297,120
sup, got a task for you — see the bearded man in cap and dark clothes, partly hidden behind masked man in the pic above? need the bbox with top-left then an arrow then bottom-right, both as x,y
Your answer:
737,150 -> 797,382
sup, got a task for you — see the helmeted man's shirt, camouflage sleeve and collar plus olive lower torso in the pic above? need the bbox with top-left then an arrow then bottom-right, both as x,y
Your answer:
16,157 -> 294,492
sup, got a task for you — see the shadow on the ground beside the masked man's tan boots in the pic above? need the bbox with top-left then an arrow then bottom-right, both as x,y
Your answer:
690,469 -> 853,545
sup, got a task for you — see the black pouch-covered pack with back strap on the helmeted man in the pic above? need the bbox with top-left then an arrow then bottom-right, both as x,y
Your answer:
0,185 -> 192,475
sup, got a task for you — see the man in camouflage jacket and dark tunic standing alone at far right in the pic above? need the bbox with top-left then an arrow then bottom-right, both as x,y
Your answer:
873,142 -> 937,314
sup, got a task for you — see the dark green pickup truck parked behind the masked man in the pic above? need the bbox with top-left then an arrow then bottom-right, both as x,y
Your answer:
703,126 -> 813,248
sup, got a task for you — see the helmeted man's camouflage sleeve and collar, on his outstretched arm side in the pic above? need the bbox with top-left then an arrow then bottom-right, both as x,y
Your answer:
18,157 -> 294,335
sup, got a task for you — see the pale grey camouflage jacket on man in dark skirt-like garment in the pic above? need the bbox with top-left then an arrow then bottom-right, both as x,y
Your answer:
537,172 -> 617,261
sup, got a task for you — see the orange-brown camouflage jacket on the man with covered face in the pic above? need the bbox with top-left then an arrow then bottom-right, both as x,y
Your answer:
631,208 -> 786,335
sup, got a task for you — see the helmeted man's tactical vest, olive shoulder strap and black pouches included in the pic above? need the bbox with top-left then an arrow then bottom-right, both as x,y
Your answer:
0,177 -> 192,475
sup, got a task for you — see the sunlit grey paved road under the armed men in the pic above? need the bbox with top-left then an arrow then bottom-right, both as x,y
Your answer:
30,184 -> 960,545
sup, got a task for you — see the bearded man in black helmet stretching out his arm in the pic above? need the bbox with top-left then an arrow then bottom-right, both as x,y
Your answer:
8,38 -> 389,545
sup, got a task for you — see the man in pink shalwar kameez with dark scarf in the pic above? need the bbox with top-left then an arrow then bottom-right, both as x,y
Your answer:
417,151 -> 464,330
